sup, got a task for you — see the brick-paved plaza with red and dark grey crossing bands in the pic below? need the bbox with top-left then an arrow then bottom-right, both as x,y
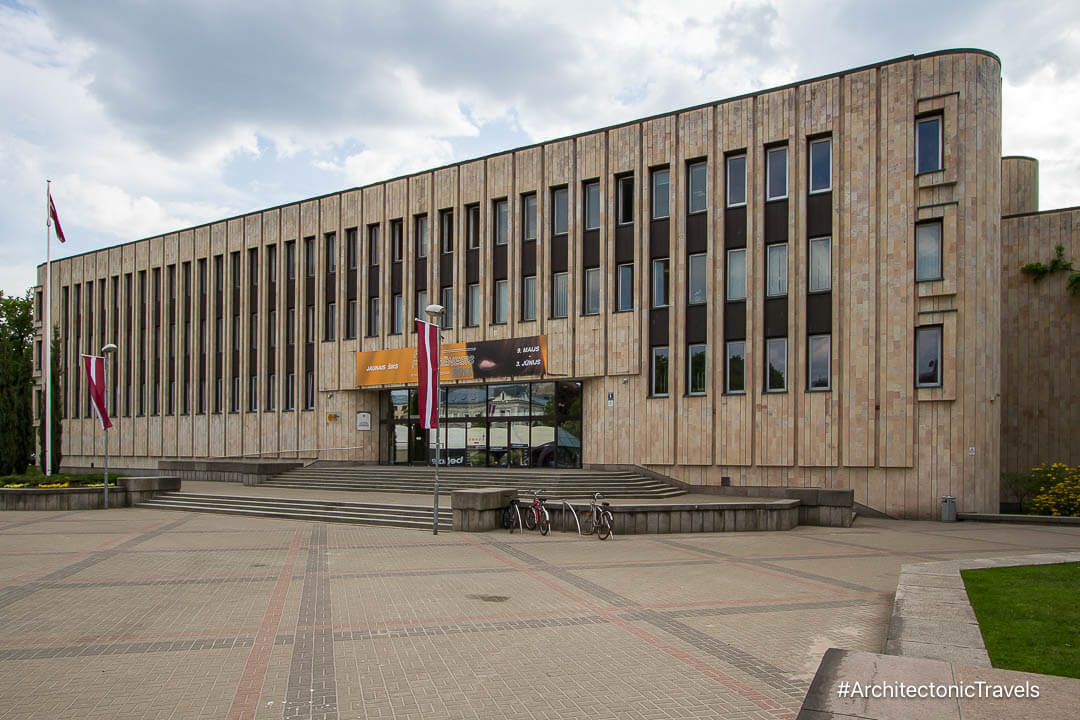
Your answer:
0,497 -> 1080,720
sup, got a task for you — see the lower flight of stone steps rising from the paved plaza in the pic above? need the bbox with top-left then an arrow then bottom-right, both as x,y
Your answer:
136,492 -> 451,530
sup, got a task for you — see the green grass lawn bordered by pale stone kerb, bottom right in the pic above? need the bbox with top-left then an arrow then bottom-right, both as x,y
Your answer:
960,562 -> 1080,678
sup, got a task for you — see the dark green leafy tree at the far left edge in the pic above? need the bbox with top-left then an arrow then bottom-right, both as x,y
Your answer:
0,290 -> 33,475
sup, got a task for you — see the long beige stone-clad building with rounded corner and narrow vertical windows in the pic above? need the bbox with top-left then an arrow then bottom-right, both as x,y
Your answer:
39,51 -> 1080,517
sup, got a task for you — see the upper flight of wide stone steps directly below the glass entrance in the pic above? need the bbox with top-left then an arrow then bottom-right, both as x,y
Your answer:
260,462 -> 686,504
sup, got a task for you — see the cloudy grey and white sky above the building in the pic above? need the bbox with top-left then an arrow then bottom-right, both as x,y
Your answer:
0,0 -> 1080,294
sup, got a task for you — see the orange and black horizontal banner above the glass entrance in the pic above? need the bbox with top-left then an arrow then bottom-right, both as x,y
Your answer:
356,336 -> 548,388
